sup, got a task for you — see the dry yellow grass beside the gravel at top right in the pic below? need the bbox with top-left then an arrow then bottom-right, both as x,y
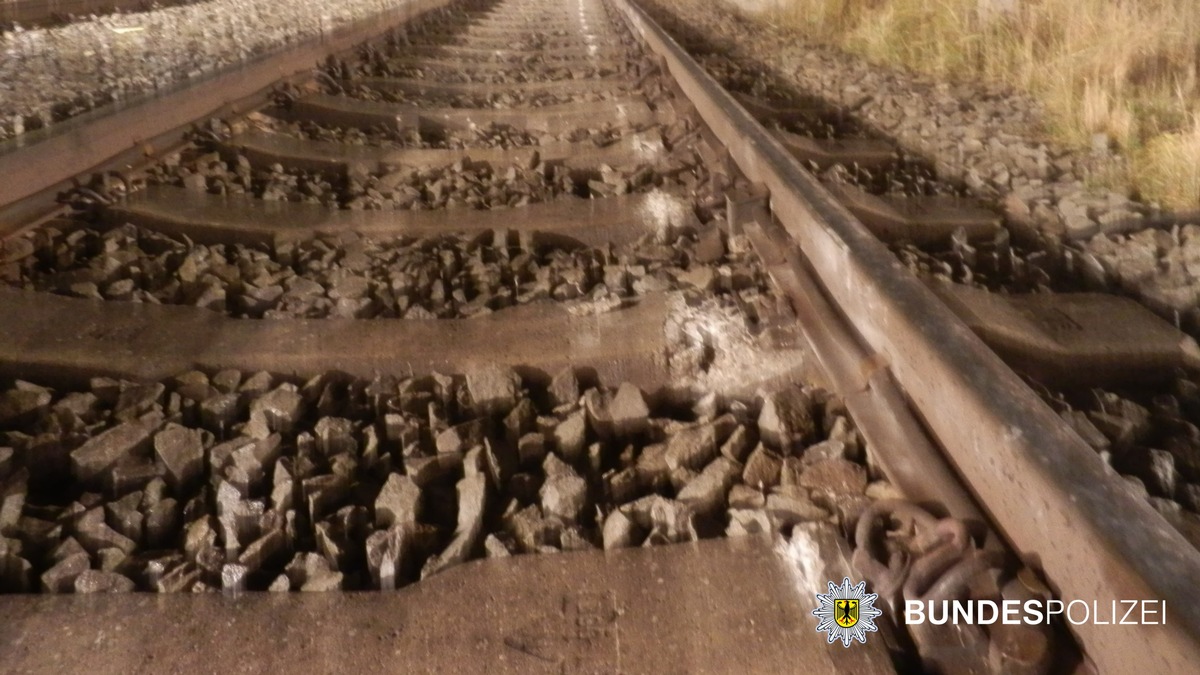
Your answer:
768,0 -> 1200,209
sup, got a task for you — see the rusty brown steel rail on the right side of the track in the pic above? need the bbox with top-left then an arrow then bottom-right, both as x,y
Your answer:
616,0 -> 1200,673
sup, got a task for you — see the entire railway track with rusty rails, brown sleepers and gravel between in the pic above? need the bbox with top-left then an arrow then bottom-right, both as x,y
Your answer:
0,0 -> 1200,673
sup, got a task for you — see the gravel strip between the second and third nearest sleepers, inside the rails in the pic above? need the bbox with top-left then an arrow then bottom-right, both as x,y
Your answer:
4,218 -> 767,319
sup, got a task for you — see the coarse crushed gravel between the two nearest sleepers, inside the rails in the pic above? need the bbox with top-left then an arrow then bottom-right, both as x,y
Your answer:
0,366 -> 895,592
